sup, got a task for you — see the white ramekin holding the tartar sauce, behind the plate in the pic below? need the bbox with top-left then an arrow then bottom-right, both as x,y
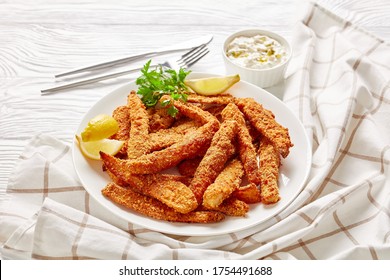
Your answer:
222,29 -> 292,88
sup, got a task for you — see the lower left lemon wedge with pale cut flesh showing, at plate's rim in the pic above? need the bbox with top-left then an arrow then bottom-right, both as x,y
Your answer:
76,135 -> 125,160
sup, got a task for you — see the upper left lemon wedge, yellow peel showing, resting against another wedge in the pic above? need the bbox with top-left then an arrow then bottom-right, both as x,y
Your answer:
81,114 -> 119,142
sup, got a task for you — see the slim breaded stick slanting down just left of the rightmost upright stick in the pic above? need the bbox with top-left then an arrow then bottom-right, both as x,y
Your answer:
222,103 -> 260,185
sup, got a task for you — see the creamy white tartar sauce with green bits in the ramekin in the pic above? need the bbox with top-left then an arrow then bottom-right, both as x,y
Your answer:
226,35 -> 287,69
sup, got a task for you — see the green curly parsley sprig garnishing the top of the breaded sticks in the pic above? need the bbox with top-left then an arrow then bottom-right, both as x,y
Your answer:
136,60 -> 190,117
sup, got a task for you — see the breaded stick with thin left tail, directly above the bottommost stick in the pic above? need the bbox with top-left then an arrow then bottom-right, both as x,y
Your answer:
103,152 -> 198,213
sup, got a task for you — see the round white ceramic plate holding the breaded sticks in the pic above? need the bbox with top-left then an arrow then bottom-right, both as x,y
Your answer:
73,73 -> 311,236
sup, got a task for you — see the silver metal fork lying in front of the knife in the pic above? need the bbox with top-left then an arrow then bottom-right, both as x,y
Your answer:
41,44 -> 209,95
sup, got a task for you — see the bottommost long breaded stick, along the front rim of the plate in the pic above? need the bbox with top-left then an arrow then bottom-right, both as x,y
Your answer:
102,183 -> 224,223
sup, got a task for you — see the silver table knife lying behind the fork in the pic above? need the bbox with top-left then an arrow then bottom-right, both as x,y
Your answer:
54,34 -> 213,78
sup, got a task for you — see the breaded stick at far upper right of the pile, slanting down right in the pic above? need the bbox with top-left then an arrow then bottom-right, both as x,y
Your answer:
234,98 -> 293,158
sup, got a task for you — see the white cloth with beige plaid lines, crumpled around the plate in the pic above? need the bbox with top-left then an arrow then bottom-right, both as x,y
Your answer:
0,4 -> 390,260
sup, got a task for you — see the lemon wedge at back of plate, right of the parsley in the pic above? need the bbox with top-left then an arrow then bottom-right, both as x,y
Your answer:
184,74 -> 240,95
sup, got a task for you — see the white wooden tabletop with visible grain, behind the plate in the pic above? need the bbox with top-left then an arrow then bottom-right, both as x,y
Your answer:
0,0 -> 390,190
